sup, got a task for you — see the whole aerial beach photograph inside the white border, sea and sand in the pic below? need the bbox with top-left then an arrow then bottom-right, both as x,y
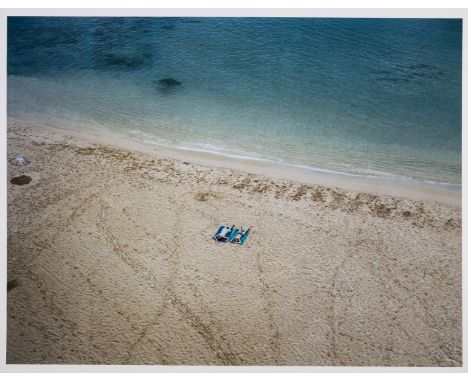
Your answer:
6,16 -> 463,367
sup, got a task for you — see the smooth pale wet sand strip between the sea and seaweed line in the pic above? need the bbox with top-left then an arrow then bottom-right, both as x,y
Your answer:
8,117 -> 462,207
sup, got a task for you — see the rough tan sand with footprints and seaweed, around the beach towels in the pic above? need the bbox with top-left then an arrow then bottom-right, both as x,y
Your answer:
7,124 -> 462,366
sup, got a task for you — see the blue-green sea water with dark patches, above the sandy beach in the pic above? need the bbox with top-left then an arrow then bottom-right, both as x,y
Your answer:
8,17 -> 462,184
